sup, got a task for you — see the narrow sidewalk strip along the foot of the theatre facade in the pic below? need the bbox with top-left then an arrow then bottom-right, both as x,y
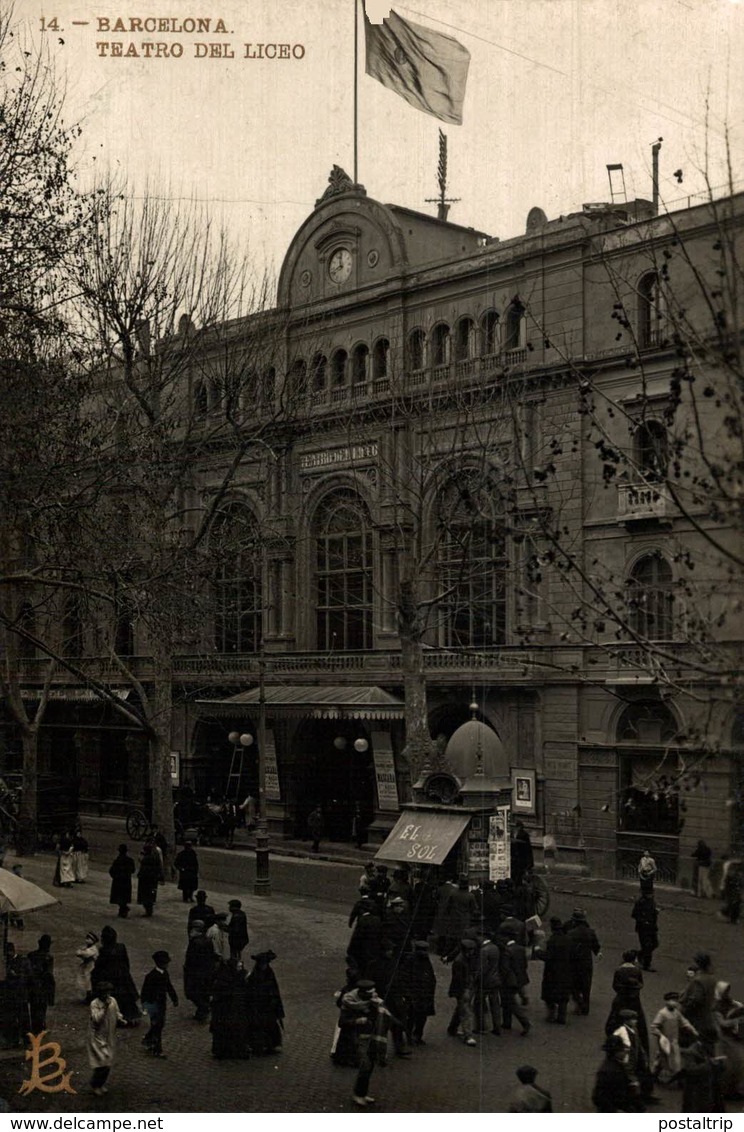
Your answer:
84,815 -> 719,917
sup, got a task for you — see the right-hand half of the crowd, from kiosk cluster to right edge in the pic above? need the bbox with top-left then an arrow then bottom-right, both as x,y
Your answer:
331,854 -> 744,1112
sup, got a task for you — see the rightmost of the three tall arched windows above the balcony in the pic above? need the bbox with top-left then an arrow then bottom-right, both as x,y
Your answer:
436,470 -> 506,648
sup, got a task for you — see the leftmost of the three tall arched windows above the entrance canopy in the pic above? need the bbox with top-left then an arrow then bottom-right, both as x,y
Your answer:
212,504 -> 263,653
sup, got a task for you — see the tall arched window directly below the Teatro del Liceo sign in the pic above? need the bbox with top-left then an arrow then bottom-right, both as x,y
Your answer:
314,490 -> 373,651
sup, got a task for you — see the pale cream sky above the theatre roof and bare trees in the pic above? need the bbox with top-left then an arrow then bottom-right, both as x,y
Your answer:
15,0 -> 744,287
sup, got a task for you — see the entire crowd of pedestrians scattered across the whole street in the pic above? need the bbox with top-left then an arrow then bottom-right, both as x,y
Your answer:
0,831 -> 744,1113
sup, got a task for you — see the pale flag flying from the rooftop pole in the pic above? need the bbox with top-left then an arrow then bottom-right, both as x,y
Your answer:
365,11 -> 470,126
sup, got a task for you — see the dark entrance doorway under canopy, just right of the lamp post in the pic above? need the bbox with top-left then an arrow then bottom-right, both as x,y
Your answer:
294,720 -> 375,841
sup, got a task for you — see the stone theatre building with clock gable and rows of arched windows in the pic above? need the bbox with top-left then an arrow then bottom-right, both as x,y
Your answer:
6,169 -> 744,881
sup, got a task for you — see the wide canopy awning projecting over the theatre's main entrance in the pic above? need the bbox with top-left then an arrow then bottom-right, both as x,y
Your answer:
196,685 -> 403,719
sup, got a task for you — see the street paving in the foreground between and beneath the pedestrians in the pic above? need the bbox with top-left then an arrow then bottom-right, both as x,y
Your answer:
0,850 -> 744,1113
